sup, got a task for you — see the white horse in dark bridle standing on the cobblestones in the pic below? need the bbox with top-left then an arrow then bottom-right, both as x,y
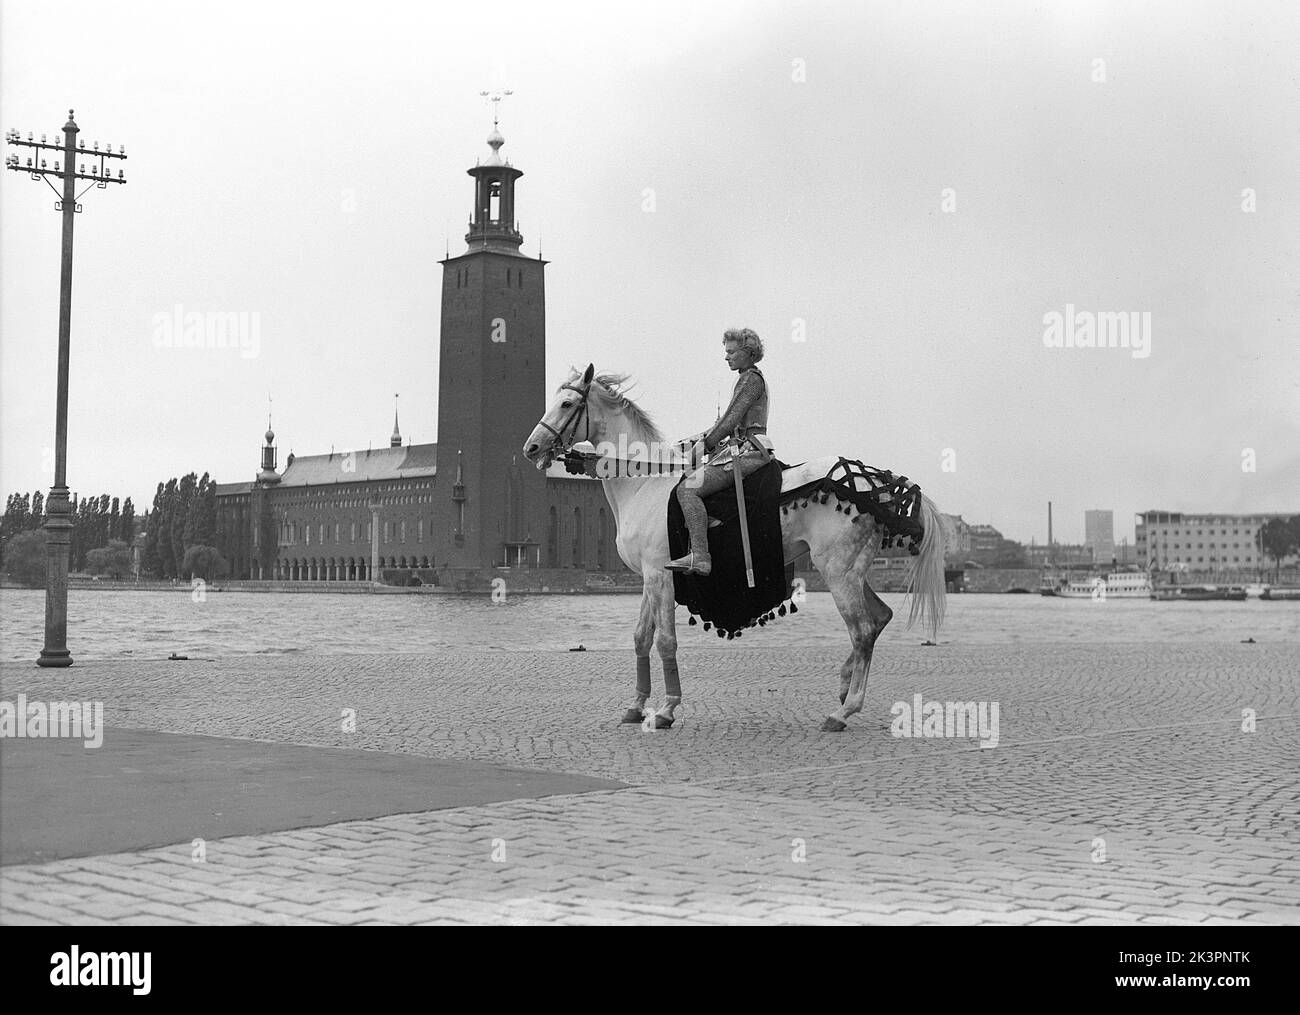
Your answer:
524,364 -> 944,733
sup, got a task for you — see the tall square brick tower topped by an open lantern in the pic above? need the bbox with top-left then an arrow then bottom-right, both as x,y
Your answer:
433,118 -> 546,568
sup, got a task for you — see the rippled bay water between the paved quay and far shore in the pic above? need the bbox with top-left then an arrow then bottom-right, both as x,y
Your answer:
0,589 -> 1300,663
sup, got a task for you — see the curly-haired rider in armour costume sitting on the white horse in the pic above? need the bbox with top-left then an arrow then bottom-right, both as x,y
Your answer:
664,328 -> 772,574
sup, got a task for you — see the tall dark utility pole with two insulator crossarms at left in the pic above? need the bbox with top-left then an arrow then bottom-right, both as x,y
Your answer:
5,109 -> 126,667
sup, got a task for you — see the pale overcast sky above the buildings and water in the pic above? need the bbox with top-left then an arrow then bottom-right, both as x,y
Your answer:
0,0 -> 1300,542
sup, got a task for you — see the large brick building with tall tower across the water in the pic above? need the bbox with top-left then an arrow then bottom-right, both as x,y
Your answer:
217,125 -> 627,584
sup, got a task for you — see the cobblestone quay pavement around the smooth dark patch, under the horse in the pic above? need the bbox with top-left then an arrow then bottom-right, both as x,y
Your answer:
0,636 -> 1300,924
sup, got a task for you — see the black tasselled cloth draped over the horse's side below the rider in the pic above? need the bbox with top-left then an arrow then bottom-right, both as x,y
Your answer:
668,459 -> 790,634
